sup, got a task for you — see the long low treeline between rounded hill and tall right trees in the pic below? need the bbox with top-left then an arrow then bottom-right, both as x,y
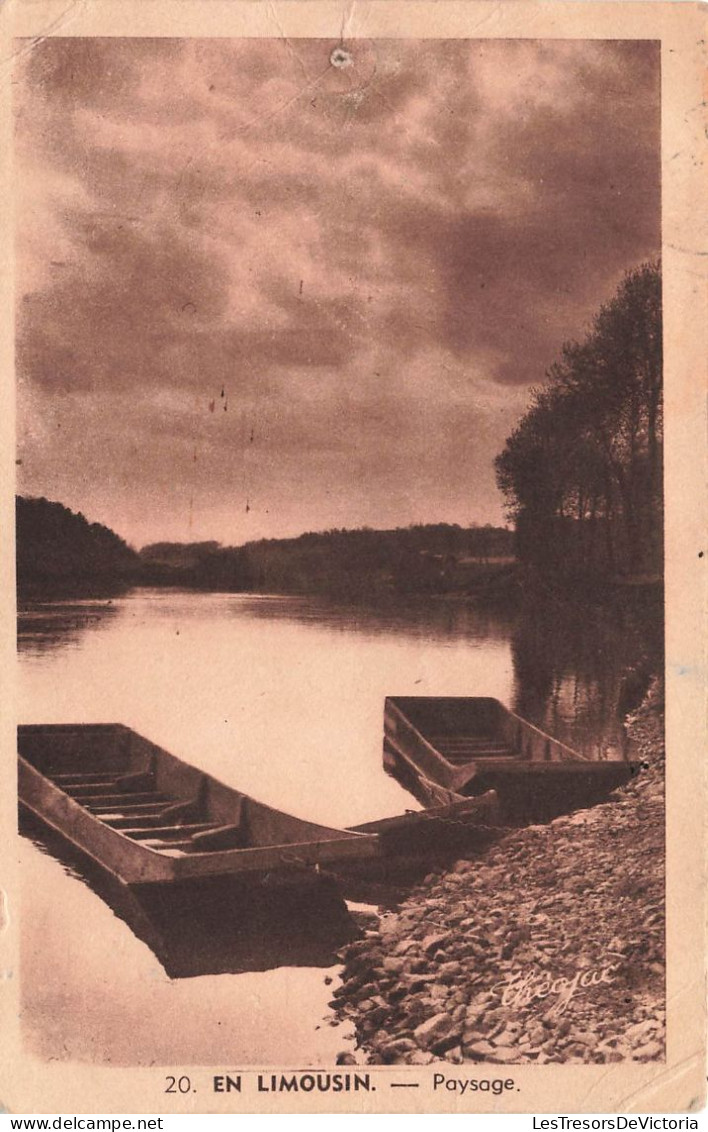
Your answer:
139,523 -> 514,598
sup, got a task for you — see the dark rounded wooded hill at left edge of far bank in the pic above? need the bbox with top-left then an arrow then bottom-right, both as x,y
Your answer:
16,497 -> 140,597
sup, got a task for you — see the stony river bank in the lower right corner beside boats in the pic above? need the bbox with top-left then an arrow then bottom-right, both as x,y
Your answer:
331,683 -> 665,1065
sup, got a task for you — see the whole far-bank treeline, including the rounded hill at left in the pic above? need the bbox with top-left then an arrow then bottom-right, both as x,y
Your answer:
17,498 -> 514,599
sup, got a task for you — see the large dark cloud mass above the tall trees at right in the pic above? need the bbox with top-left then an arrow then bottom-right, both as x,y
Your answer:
342,43 -> 660,384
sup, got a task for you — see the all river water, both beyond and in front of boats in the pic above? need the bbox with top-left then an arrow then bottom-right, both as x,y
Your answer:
19,589 -> 660,1066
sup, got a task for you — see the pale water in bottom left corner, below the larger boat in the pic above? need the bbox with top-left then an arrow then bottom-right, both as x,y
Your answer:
19,838 -> 353,1066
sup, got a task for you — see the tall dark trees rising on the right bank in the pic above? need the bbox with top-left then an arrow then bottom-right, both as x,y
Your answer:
496,264 -> 663,581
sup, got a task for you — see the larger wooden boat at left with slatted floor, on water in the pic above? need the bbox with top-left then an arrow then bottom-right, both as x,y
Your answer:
18,723 -> 382,885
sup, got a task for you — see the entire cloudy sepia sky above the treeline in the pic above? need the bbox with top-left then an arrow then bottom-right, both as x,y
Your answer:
15,38 -> 659,546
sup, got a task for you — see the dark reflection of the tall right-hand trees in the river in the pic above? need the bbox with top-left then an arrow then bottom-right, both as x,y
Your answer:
512,594 -> 663,757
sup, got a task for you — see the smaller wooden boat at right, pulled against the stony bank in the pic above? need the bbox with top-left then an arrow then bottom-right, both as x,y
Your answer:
384,696 -> 638,817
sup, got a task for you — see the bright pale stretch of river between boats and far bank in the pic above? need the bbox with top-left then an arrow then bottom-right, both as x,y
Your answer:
19,590 -> 512,827
